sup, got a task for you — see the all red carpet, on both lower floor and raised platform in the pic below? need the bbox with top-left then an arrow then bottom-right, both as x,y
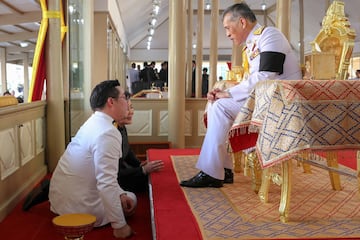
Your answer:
0,149 -> 356,240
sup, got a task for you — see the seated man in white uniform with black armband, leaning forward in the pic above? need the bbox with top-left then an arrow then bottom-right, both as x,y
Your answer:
180,3 -> 301,187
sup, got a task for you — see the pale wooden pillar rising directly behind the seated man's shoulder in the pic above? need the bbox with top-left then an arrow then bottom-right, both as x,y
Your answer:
276,0 -> 291,40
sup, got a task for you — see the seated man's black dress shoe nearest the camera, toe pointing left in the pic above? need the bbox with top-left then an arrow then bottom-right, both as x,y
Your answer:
180,171 -> 224,188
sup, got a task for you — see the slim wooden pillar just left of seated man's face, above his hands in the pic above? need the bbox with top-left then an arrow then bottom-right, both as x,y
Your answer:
208,0 -> 219,90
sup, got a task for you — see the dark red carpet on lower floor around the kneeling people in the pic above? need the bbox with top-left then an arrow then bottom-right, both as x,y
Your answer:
0,185 -> 152,240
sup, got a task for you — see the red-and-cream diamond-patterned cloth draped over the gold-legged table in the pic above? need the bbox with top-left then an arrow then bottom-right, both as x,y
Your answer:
229,80 -> 360,167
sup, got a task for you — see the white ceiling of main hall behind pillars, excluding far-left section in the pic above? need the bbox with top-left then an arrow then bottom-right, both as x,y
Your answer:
118,0 -> 360,60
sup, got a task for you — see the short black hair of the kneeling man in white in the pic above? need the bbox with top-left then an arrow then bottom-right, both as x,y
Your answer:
90,80 -> 120,111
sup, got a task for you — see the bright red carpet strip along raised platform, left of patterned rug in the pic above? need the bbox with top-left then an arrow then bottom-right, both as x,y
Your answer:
147,149 -> 202,240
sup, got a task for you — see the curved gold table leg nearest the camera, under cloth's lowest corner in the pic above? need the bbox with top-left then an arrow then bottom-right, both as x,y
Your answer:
279,160 -> 292,223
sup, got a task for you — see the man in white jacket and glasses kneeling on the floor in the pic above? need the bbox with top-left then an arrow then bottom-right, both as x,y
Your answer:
49,80 -> 137,238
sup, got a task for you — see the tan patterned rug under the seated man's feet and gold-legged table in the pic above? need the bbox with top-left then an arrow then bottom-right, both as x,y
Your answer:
171,156 -> 360,240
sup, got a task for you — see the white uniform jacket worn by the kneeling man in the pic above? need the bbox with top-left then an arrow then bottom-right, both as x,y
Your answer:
49,112 -> 126,228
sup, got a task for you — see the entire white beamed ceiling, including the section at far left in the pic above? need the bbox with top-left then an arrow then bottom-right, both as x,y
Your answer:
0,0 -> 360,61
